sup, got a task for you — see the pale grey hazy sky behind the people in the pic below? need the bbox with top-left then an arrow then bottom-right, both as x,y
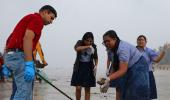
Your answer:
0,0 -> 170,71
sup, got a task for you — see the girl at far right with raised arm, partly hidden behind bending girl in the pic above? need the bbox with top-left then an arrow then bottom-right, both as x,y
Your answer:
136,35 -> 167,99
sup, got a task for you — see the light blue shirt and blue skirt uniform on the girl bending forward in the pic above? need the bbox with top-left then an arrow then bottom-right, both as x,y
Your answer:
111,40 -> 150,100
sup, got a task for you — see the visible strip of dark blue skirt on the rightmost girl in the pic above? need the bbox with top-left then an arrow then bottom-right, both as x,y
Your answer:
149,71 -> 157,99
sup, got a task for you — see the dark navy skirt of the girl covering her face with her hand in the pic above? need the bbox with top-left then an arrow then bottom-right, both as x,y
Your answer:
71,62 -> 96,87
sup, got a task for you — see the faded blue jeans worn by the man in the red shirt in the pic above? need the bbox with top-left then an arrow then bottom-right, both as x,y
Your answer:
4,52 -> 33,100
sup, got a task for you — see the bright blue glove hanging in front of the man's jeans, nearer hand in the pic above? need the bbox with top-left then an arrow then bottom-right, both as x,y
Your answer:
24,61 -> 35,82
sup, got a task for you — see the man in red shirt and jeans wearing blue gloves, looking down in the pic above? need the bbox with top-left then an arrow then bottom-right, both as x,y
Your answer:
3,5 -> 57,100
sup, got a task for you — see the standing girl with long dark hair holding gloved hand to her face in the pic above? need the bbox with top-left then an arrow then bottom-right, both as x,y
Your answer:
71,32 -> 98,100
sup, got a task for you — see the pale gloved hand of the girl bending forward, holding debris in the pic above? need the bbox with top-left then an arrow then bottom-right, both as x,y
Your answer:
100,77 -> 110,93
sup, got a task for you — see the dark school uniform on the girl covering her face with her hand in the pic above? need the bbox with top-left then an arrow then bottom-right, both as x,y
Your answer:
71,40 -> 98,87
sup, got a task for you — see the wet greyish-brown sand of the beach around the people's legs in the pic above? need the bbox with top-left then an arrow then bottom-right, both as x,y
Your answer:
0,70 -> 170,100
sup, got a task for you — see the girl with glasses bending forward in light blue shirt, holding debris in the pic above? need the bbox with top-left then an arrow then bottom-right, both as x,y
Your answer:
101,30 -> 150,100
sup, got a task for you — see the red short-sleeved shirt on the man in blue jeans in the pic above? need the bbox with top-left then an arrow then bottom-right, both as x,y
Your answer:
6,13 -> 44,50
